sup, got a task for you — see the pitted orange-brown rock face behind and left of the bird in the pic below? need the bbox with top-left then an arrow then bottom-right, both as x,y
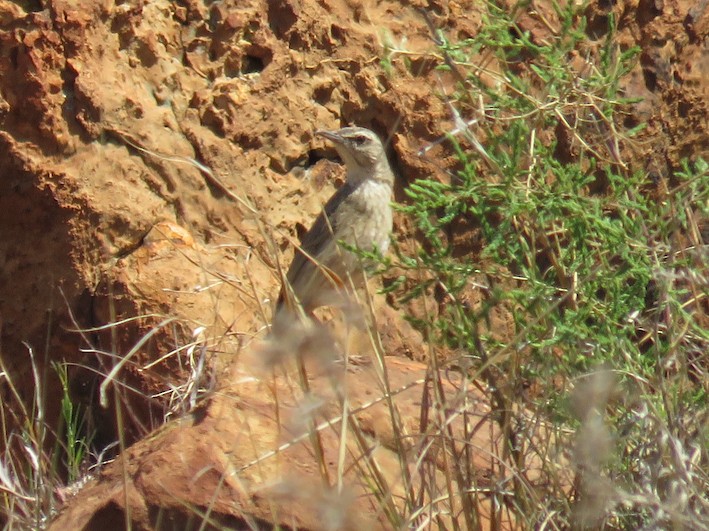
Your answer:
0,1 -> 456,458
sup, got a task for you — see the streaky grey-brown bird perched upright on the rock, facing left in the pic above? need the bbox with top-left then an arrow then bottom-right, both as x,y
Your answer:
272,127 -> 394,330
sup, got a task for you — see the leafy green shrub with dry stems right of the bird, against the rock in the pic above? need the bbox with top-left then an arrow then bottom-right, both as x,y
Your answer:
389,3 -> 709,529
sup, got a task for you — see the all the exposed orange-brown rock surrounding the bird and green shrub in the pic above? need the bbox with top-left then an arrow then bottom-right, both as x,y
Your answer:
0,0 -> 709,530
